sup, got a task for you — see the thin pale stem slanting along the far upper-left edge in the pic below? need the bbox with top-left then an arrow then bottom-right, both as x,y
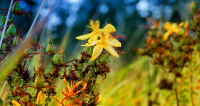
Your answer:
0,0 -> 14,48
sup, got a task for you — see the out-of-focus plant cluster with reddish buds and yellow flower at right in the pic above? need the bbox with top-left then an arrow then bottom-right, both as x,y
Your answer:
136,2 -> 200,106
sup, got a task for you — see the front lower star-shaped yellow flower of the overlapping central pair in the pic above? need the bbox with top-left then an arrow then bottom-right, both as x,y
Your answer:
81,32 -> 121,60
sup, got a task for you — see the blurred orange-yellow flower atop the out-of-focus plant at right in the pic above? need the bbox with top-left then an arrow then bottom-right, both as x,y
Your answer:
163,22 -> 184,41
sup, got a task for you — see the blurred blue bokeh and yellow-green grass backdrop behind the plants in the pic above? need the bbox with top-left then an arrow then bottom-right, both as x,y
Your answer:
0,0 -> 200,106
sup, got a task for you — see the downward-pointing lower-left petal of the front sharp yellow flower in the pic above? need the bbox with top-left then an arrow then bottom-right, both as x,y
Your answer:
92,44 -> 103,60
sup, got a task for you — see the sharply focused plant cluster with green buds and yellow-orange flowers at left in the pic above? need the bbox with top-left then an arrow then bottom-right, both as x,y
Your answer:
0,1 -> 123,106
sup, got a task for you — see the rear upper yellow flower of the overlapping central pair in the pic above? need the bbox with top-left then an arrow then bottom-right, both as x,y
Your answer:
76,20 -> 116,43
